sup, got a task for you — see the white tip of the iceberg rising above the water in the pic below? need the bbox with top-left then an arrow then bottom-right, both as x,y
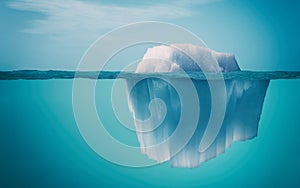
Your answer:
136,44 -> 240,72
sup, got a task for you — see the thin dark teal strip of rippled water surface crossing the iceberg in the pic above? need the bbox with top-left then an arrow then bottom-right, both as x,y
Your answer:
0,70 -> 300,80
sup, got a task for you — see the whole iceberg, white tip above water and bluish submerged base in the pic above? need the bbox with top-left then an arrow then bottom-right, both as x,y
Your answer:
126,44 -> 269,168
